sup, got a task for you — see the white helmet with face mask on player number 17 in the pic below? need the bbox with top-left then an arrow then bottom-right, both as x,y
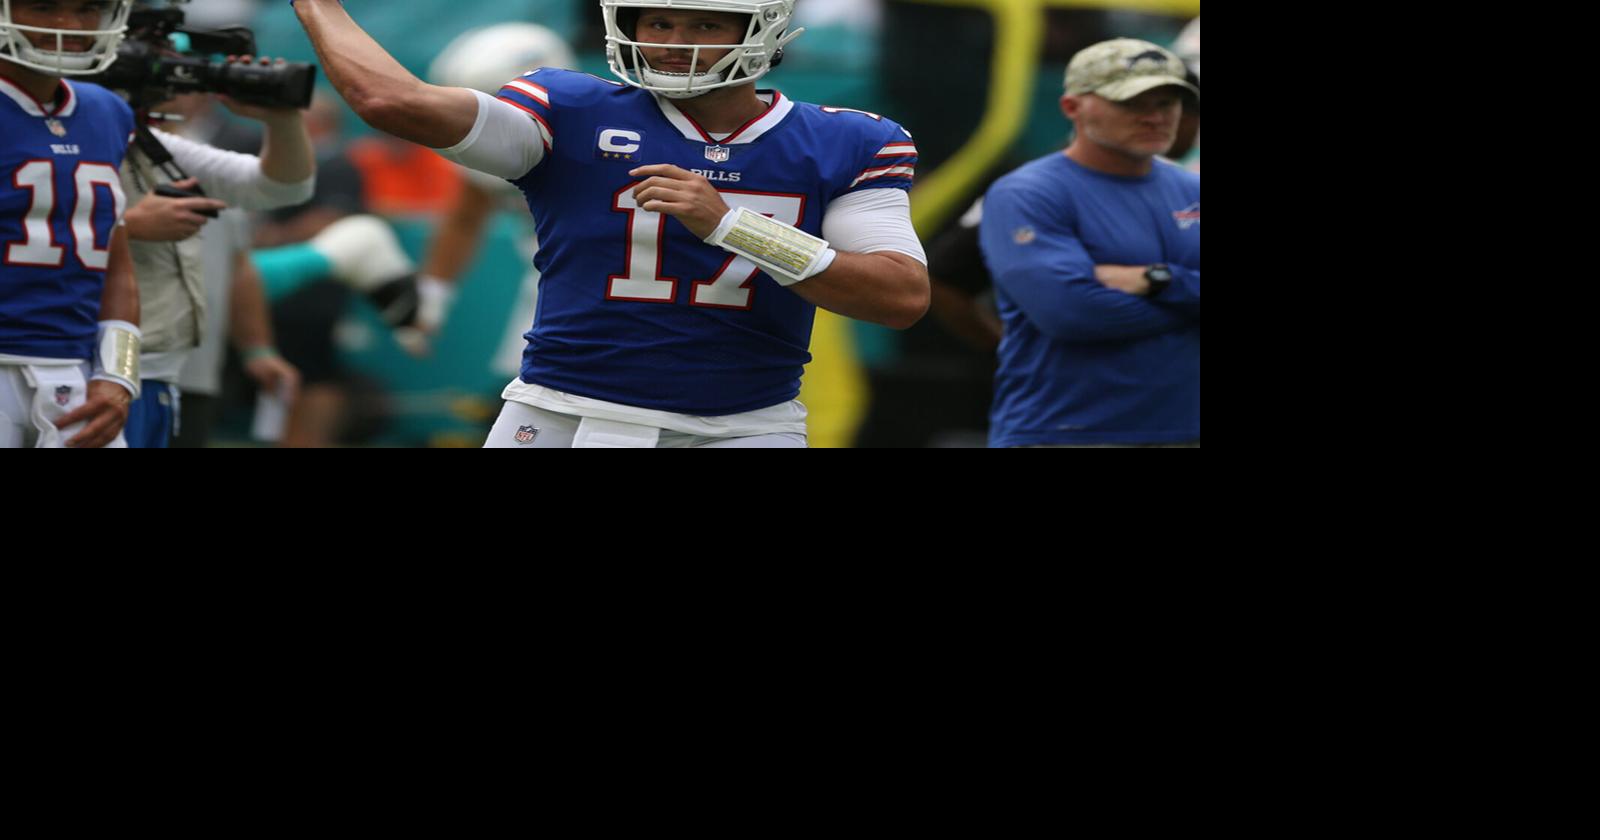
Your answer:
600,0 -> 805,99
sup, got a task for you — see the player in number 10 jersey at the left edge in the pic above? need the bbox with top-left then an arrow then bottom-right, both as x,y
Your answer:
0,0 -> 139,448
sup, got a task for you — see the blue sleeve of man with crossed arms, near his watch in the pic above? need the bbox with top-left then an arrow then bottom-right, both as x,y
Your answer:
981,184 -> 1198,342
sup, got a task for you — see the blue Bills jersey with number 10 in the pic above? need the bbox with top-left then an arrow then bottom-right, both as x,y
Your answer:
0,77 -> 134,358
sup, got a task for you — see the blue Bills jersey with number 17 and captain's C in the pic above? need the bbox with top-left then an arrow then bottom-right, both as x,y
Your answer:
499,69 -> 917,416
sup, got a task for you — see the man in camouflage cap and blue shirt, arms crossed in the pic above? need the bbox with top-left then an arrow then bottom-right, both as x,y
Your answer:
981,38 -> 1200,446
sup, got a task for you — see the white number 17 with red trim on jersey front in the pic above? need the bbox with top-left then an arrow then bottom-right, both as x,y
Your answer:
606,184 -> 805,309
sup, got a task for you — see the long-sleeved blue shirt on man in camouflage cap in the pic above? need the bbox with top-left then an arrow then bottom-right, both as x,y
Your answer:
981,154 -> 1200,446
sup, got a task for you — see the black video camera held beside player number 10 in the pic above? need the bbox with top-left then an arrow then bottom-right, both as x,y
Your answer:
90,6 -> 317,110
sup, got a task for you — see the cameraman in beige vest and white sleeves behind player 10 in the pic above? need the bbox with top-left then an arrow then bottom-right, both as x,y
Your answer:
122,56 -> 317,448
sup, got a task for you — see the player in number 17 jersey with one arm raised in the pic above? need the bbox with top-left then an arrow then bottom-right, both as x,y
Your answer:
296,0 -> 928,448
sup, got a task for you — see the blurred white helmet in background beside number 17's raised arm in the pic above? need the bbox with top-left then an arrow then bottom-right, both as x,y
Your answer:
427,24 -> 578,96
